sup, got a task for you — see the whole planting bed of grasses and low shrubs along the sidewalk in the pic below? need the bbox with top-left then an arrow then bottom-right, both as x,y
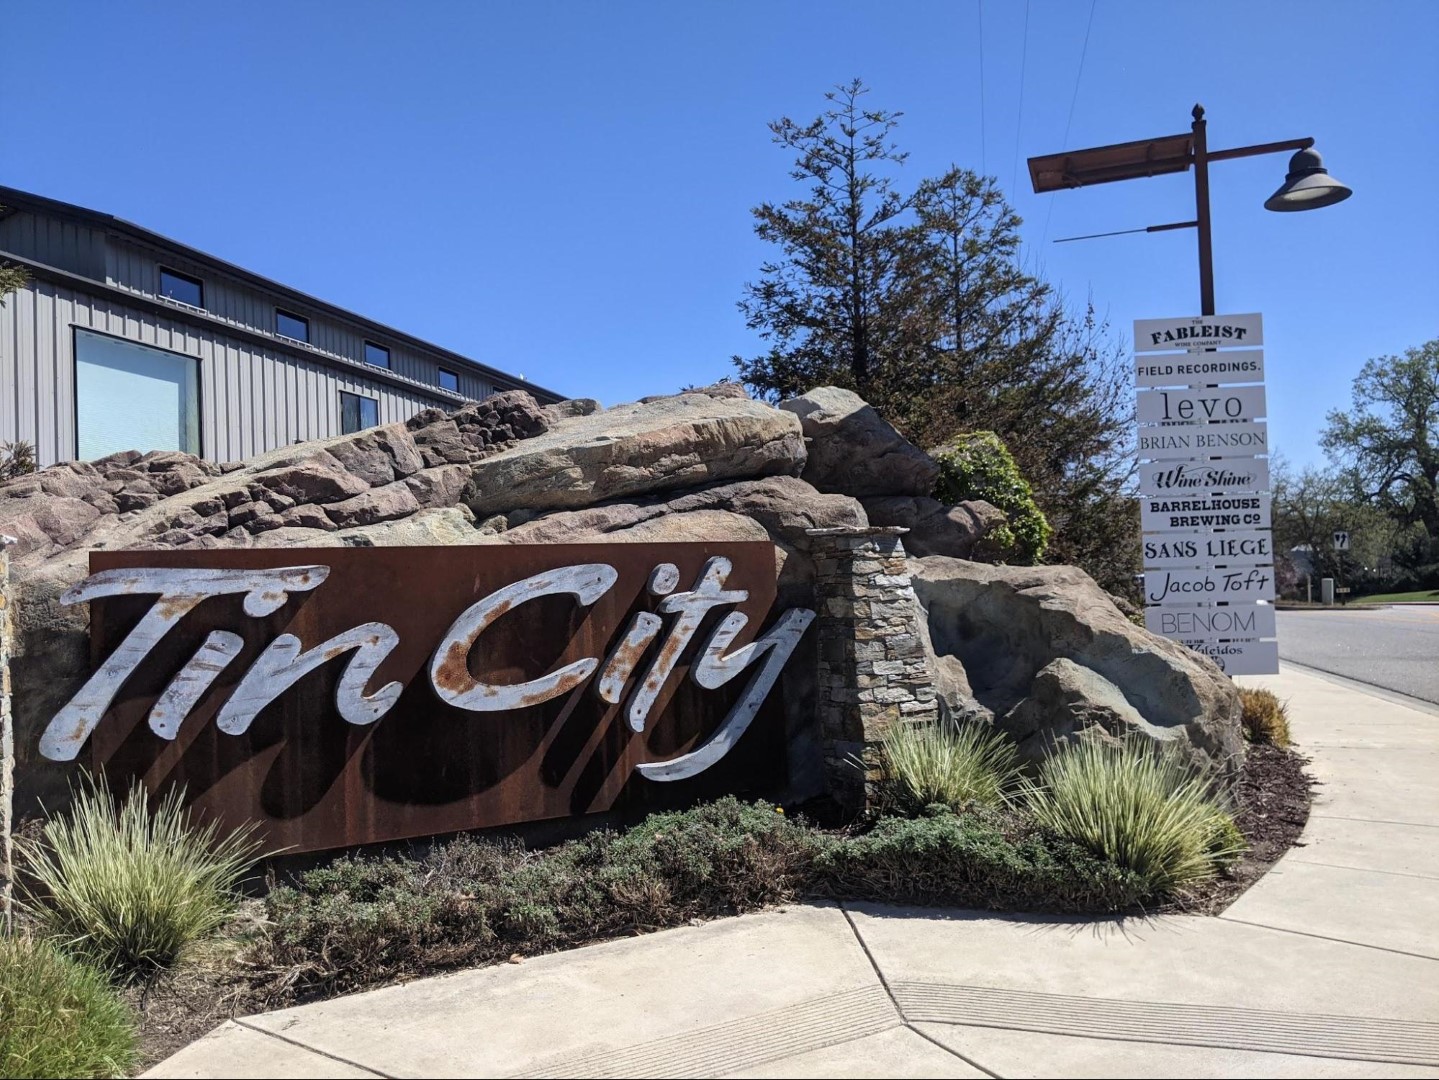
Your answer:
0,729 -> 1309,1076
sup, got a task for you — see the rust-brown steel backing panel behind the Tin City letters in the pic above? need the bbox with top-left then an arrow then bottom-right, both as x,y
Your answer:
89,542 -> 786,851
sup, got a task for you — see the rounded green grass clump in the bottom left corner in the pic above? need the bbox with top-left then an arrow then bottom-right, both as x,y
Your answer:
0,936 -> 135,1079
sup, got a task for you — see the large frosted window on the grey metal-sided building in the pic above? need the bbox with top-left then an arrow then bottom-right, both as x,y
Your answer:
75,329 -> 200,462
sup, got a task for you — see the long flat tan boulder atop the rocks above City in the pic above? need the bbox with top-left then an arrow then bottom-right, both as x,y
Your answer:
465,393 -> 804,518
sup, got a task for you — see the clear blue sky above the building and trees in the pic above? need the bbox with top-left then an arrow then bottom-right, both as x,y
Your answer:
0,0 -> 1439,462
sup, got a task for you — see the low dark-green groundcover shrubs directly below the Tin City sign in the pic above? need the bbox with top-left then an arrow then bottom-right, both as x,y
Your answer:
253,798 -> 817,991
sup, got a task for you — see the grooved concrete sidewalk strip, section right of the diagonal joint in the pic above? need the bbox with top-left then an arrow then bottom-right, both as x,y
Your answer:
894,982 -> 1439,1066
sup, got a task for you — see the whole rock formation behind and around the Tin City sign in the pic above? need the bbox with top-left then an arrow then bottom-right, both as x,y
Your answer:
0,384 -> 1239,798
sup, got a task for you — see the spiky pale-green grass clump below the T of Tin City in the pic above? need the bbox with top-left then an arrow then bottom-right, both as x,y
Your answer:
17,784 -> 258,981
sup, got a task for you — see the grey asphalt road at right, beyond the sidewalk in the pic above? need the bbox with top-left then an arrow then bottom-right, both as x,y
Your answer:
1278,605 -> 1439,705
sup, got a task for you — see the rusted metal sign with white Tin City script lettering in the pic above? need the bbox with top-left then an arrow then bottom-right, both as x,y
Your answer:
40,541 -> 814,851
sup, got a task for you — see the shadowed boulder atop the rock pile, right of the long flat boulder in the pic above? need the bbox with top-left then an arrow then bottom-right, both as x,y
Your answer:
780,387 -> 940,498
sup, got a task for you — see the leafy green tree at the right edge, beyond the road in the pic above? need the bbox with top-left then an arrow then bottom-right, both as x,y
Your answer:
1321,339 -> 1439,541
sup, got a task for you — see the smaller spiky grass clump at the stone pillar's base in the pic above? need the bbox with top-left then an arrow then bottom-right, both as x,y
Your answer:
881,720 -> 1019,817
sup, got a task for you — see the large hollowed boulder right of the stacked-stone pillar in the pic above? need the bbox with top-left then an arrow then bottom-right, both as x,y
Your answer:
911,557 -> 1243,775
